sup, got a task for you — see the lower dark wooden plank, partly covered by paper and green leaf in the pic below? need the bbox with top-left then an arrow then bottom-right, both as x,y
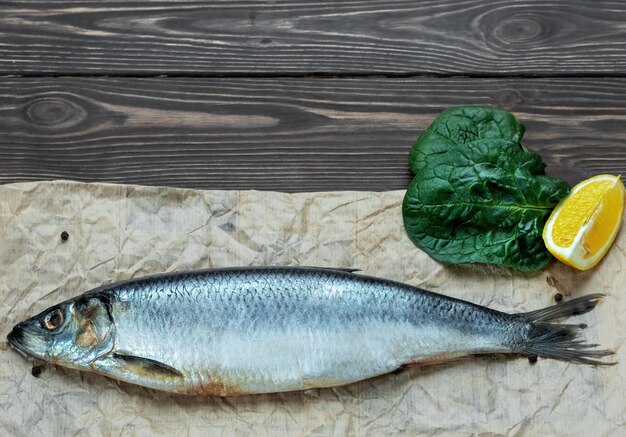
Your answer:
0,78 -> 626,191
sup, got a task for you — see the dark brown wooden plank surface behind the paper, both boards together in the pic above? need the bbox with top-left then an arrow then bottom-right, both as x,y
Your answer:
0,0 -> 626,192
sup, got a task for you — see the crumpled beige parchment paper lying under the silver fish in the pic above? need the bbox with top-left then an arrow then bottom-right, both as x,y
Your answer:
0,181 -> 626,436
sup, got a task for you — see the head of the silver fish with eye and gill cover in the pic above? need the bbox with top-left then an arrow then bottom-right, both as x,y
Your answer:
7,296 -> 115,370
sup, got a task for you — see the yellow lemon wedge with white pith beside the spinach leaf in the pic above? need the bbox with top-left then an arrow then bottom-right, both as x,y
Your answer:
543,174 -> 624,270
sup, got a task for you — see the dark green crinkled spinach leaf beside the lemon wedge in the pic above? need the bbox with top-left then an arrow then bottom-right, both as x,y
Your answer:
402,107 -> 570,271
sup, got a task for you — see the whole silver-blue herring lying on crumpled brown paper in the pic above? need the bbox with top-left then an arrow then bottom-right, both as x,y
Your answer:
7,267 -> 614,396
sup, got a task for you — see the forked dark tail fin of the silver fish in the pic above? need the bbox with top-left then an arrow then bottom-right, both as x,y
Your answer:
519,293 -> 617,365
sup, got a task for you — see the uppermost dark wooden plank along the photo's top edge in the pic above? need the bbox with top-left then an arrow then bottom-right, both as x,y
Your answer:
0,0 -> 626,76
